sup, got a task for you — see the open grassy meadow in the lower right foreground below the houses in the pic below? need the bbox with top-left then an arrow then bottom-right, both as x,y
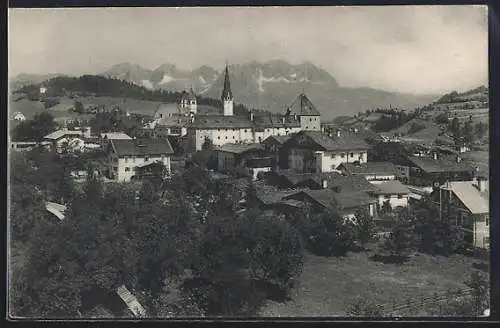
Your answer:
260,252 -> 477,317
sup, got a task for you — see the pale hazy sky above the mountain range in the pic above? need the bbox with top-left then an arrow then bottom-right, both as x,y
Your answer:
8,6 -> 488,94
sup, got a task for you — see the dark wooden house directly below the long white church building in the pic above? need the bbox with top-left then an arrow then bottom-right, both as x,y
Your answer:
214,143 -> 273,180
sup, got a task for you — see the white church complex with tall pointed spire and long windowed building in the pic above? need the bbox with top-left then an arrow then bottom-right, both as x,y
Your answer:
155,66 -> 321,151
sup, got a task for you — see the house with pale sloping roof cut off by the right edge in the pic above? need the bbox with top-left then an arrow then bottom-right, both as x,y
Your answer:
431,178 -> 490,248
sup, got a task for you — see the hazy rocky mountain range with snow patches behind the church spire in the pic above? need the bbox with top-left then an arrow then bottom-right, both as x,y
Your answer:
11,60 -> 438,120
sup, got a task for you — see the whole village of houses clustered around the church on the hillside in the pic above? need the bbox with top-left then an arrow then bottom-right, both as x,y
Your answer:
10,67 -> 490,313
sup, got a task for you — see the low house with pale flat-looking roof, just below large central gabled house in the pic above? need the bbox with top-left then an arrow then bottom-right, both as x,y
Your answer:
337,162 -> 396,181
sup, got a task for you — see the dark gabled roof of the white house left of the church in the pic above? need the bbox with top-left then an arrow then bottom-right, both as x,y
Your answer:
111,139 -> 174,156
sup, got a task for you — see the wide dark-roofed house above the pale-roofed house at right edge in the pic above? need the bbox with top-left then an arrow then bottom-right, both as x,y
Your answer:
393,152 -> 475,186
